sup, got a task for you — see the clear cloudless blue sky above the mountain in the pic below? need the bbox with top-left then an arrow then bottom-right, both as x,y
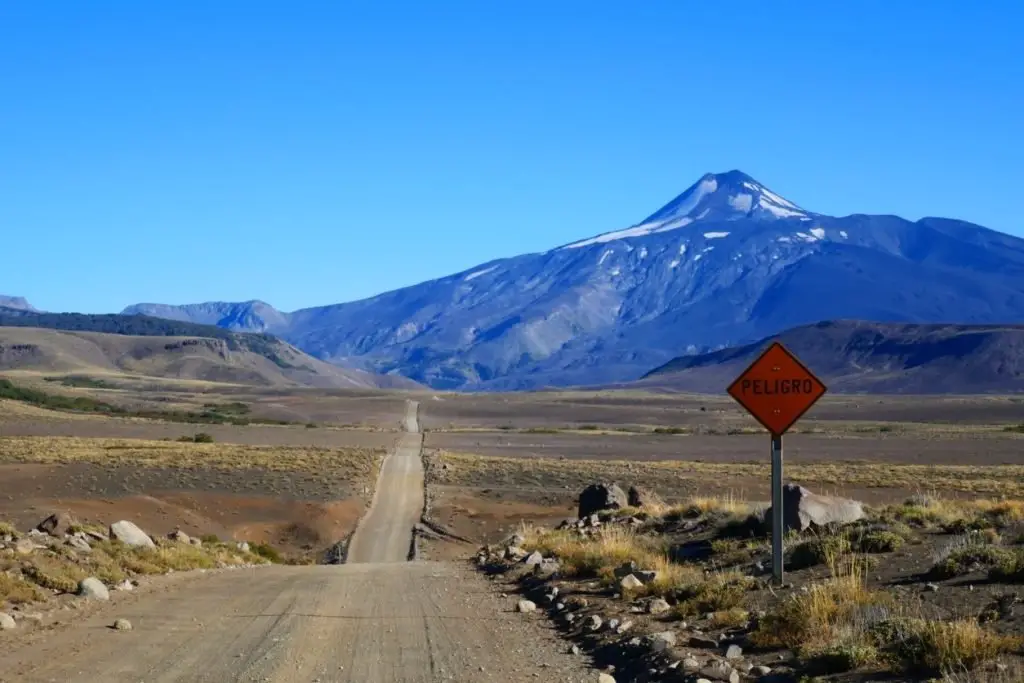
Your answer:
0,0 -> 1024,312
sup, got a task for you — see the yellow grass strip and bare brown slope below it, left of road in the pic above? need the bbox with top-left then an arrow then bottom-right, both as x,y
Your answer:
0,436 -> 384,555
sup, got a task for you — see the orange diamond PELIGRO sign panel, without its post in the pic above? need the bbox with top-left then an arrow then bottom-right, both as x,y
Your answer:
728,342 -> 826,436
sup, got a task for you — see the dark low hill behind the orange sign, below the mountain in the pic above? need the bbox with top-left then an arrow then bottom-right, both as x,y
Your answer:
627,321 -> 1024,394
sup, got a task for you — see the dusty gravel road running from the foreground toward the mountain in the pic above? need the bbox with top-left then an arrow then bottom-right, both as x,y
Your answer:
0,407 -> 596,683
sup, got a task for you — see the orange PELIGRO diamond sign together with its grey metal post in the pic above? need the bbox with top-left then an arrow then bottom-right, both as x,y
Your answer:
728,342 -> 827,584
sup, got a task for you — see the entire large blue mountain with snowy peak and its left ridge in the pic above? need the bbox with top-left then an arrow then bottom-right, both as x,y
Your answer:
123,171 -> 1024,389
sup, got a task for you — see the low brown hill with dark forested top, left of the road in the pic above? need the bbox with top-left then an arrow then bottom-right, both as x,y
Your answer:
0,308 -> 420,388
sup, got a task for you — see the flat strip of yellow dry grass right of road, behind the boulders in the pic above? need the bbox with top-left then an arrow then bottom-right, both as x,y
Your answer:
439,452 -> 1024,499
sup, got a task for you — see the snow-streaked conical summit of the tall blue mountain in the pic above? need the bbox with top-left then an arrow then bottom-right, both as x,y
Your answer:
563,171 -> 812,249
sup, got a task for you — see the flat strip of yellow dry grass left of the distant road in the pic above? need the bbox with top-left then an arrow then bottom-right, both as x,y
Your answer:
0,436 -> 384,478
